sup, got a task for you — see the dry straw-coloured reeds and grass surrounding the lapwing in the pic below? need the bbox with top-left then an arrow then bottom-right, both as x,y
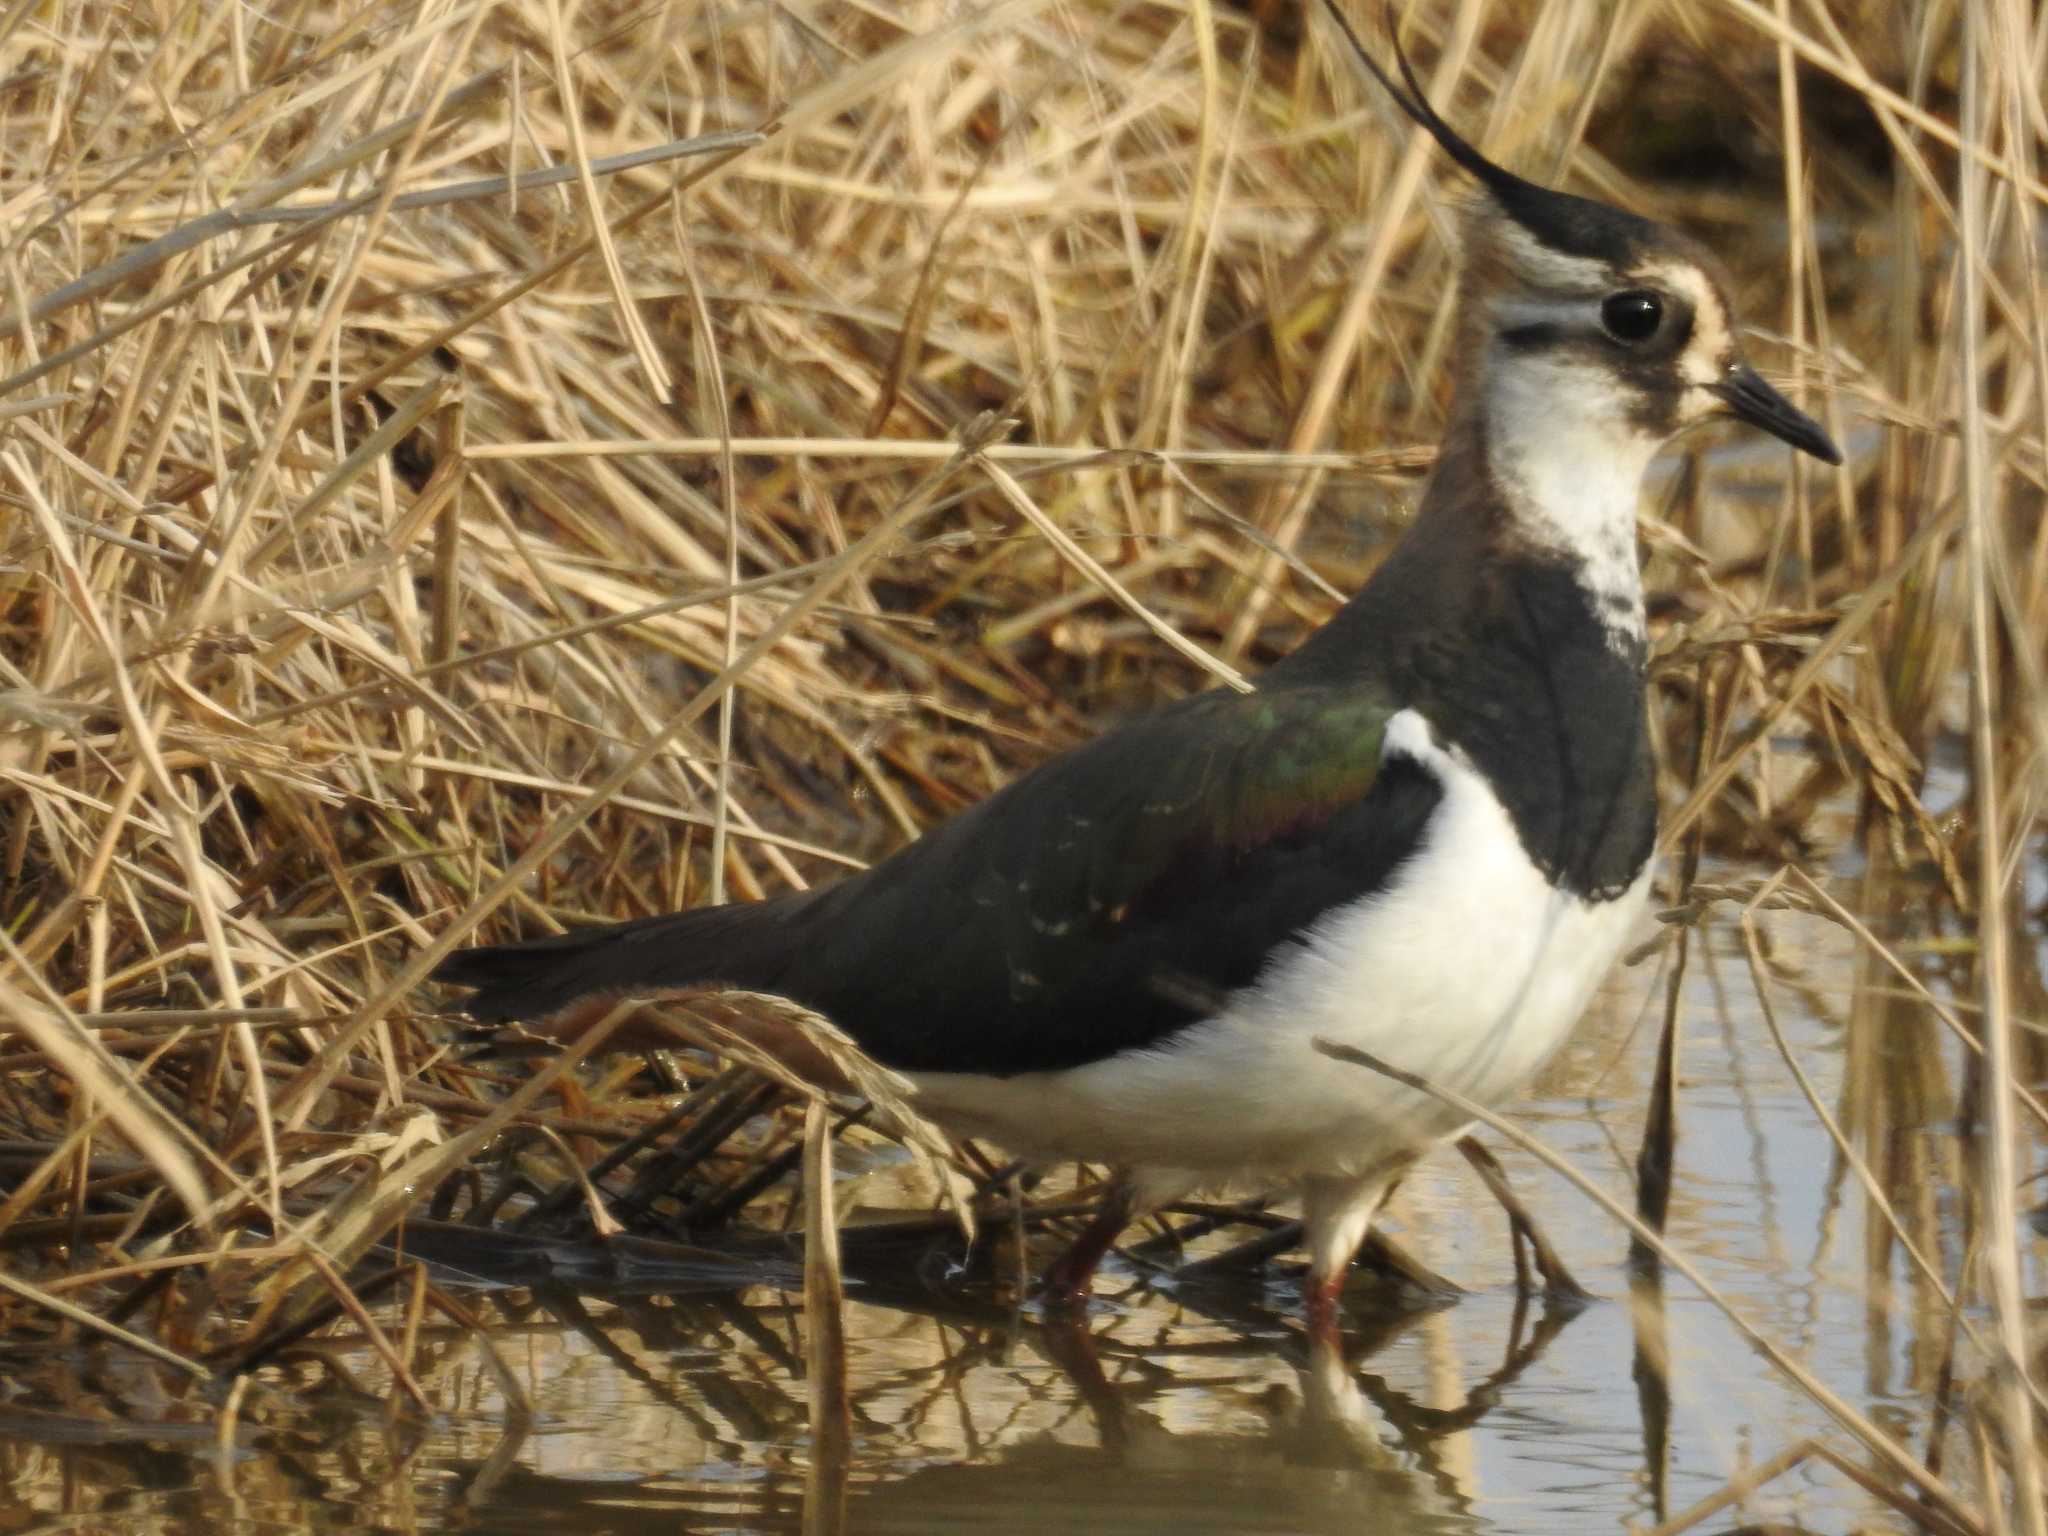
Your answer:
0,0 -> 2048,1532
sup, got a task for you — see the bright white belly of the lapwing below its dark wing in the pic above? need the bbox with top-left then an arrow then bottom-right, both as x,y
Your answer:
913,711 -> 1649,1180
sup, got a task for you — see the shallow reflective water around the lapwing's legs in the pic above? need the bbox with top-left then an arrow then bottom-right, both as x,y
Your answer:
0,856 -> 2015,1534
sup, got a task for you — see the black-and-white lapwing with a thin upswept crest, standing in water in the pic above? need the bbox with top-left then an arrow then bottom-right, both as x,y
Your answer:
432,2 -> 1841,1333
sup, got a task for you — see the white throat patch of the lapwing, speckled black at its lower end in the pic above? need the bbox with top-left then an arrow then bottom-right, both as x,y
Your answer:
1485,346 -> 1663,643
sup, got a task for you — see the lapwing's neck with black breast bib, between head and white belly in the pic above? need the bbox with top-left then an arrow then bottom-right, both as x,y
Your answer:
1262,385 -> 1657,899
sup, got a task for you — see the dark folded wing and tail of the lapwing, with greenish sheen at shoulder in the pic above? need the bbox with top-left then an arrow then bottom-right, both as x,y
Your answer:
434,686 -> 1442,1075
